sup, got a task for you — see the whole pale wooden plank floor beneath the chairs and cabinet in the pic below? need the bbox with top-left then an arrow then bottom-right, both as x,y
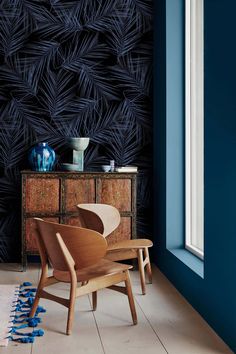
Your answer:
0,264 -> 232,354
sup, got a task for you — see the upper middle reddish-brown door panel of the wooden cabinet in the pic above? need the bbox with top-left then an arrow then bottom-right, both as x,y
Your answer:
65,178 -> 95,212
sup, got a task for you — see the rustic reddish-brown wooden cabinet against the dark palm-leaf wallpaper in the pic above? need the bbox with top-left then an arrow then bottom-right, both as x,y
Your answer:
22,171 -> 136,268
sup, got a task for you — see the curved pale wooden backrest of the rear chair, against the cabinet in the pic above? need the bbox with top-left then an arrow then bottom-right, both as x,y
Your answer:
77,203 -> 120,237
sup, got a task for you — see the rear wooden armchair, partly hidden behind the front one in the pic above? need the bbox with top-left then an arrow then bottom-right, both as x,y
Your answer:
77,203 -> 153,294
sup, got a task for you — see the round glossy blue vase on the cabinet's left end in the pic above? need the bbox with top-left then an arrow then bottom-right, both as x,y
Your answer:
29,143 -> 56,172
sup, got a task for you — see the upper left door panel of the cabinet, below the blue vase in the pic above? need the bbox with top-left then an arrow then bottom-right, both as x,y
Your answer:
25,178 -> 60,213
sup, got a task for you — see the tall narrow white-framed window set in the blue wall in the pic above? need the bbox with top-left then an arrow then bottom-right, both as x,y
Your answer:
185,0 -> 204,259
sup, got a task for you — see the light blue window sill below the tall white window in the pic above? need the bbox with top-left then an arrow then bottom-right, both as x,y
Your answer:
168,248 -> 204,278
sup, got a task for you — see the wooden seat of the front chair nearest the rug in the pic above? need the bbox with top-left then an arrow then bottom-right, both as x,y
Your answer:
53,259 -> 132,283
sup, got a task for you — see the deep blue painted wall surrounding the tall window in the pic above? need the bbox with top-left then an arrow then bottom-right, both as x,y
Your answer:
154,0 -> 236,351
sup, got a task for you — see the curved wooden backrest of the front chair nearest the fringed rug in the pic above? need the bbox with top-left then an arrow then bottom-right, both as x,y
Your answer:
34,218 -> 107,271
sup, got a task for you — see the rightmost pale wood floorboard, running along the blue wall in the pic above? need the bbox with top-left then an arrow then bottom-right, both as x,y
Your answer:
132,267 -> 232,354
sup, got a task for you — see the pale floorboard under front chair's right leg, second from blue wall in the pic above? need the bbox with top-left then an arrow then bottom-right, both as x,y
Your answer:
89,290 -> 166,354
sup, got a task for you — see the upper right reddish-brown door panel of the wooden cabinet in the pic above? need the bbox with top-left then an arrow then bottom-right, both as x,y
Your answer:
100,178 -> 132,211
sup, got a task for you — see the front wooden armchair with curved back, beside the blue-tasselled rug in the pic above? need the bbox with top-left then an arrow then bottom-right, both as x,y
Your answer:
30,218 -> 137,334
